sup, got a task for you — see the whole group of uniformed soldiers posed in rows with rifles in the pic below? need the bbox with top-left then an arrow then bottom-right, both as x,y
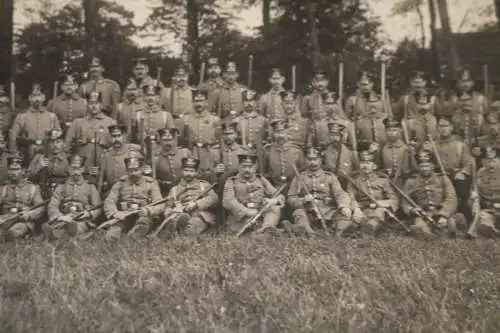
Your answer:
0,53 -> 500,240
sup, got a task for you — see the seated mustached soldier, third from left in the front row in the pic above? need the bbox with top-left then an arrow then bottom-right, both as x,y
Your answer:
104,157 -> 164,239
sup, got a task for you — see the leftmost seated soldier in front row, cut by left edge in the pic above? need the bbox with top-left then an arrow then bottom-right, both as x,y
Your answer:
0,156 -> 45,239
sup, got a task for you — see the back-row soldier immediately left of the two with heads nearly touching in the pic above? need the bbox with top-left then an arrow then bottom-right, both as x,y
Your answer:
165,66 -> 194,131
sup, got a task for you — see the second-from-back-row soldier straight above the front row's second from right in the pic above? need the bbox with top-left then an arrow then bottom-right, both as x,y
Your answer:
403,89 -> 439,147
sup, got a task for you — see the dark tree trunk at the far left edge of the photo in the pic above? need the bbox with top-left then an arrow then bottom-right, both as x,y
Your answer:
0,0 -> 15,86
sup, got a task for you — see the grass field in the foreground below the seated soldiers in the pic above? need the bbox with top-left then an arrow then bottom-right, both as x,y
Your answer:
0,236 -> 500,333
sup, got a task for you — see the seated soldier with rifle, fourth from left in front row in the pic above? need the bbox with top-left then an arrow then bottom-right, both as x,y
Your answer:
158,158 -> 219,236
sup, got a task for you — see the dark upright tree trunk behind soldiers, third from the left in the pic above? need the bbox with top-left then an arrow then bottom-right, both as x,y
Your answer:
186,0 -> 200,82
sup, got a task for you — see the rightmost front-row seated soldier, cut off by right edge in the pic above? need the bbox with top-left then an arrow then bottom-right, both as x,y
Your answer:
470,147 -> 500,237
